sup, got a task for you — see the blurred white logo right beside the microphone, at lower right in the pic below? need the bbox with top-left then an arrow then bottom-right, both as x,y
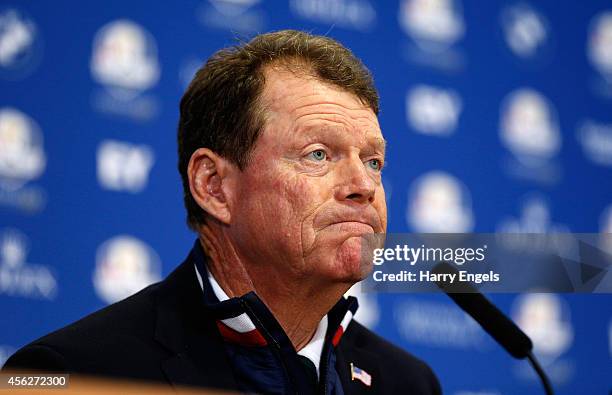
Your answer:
512,294 -> 574,364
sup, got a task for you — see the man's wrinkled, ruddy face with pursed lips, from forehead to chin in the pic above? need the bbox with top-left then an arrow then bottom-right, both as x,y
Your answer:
231,69 -> 387,283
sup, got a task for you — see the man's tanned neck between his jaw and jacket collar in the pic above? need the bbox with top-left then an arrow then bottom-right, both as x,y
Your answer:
200,227 -> 349,351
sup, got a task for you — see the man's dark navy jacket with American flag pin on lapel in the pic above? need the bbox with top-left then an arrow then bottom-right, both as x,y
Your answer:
4,243 -> 441,395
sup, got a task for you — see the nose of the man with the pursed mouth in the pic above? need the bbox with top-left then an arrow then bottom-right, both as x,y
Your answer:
336,157 -> 376,203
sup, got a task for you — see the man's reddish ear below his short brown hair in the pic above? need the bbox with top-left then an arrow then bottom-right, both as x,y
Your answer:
187,148 -> 239,224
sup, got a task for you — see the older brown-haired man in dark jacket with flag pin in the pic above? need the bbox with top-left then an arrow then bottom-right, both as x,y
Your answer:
1,31 -> 440,394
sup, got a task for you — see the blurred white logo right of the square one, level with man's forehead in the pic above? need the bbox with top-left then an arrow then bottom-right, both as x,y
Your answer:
500,88 -> 561,164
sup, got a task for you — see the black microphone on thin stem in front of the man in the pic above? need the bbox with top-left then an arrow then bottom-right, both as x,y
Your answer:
433,262 -> 553,395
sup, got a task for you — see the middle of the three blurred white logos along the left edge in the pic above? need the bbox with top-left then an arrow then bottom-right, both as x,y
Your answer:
0,107 -> 46,190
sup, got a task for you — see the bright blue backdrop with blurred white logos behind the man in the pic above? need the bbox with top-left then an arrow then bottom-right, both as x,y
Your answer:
0,0 -> 612,395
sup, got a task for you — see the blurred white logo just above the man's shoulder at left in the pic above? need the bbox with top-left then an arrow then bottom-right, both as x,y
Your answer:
93,235 -> 161,304
